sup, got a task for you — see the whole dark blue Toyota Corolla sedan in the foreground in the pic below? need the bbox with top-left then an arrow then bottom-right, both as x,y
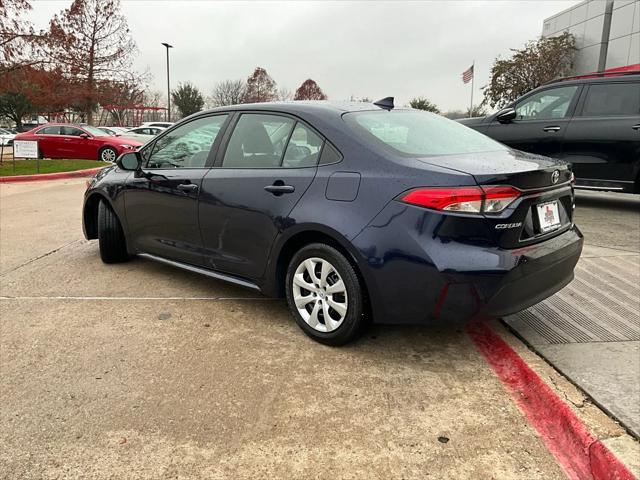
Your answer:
83,99 -> 583,345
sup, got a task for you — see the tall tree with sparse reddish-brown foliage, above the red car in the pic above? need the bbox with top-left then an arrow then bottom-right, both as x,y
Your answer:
50,0 -> 136,123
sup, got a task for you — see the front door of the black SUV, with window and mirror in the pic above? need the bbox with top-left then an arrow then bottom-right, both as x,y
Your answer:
486,85 -> 581,158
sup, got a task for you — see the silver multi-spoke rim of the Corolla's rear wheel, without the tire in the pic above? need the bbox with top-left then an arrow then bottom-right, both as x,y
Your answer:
292,257 -> 348,332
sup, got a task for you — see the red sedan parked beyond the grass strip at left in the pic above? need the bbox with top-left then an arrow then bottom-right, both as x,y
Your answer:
15,123 -> 142,162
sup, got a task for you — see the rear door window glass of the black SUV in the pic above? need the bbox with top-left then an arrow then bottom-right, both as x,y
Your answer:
582,83 -> 640,117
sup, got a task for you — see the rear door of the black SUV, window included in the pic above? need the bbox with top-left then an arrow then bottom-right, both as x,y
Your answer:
564,81 -> 640,191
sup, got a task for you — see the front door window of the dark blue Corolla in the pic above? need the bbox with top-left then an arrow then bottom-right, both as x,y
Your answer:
147,115 -> 228,168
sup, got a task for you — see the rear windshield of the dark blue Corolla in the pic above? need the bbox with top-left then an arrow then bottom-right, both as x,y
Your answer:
344,110 -> 507,157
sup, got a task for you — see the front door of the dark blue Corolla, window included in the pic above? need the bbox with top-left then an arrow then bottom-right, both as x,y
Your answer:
125,114 -> 228,265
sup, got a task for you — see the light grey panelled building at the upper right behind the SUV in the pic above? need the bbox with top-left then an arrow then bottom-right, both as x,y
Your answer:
542,0 -> 640,75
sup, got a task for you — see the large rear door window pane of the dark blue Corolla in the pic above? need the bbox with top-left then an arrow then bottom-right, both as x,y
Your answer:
222,113 -> 296,168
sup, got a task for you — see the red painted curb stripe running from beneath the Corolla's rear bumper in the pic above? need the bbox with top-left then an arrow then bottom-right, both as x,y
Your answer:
466,322 -> 635,480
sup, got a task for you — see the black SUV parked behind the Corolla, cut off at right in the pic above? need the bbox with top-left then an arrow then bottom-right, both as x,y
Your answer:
460,71 -> 640,193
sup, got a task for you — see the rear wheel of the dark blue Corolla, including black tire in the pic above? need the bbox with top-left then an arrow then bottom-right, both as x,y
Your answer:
285,243 -> 365,346
